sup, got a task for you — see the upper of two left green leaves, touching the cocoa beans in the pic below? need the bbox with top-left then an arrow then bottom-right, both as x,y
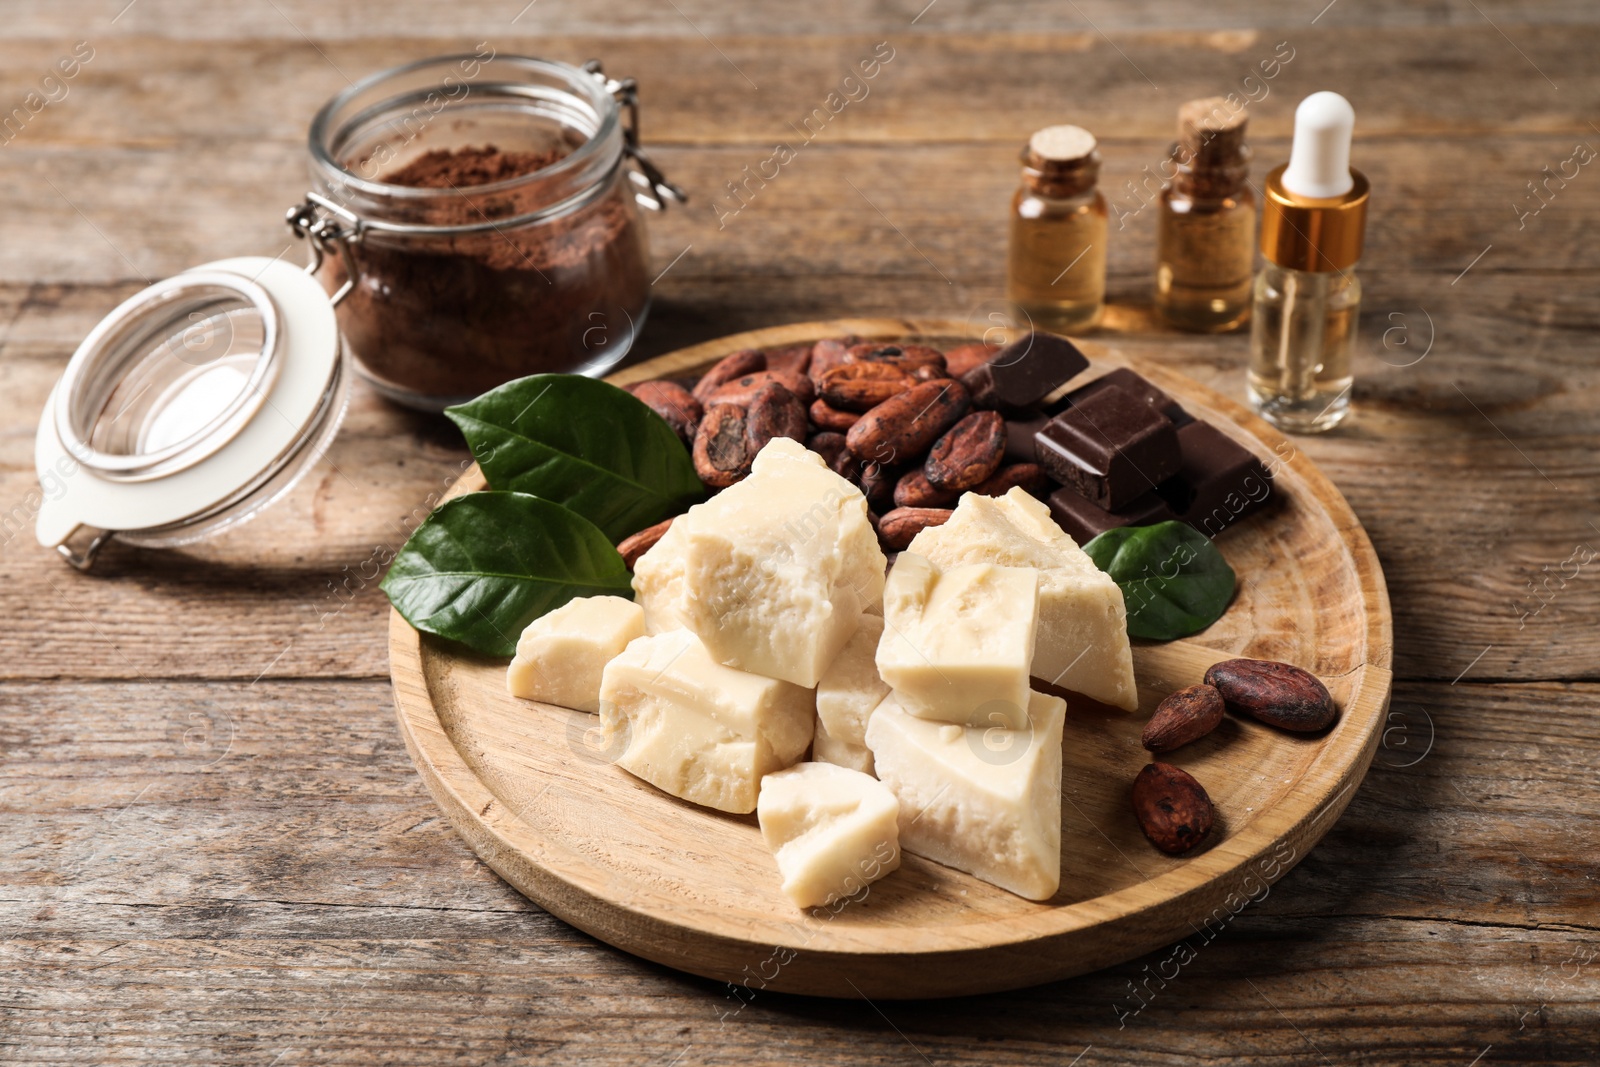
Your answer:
445,374 -> 706,544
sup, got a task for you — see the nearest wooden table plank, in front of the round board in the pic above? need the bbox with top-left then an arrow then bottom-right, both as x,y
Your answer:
0,680 -> 1600,1067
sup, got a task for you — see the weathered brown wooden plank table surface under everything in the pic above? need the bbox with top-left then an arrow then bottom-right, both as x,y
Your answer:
0,0 -> 1600,1067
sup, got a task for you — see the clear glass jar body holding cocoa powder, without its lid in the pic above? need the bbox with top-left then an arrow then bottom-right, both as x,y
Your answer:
290,48 -> 682,410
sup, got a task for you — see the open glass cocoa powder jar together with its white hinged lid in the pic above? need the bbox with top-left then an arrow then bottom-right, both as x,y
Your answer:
22,50 -> 683,569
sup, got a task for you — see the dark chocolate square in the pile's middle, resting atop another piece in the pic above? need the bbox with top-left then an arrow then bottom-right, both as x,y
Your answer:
1034,386 -> 1179,512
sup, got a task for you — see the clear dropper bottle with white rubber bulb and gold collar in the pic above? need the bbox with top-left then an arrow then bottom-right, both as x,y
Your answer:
1250,93 -> 1368,434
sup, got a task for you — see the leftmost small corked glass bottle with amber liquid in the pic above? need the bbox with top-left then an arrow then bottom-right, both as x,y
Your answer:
1006,126 -> 1107,333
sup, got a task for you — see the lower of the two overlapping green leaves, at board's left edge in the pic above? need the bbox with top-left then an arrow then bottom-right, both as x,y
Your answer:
382,493 -> 634,656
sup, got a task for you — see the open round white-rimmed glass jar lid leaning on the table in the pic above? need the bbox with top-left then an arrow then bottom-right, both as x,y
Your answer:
34,258 -> 347,568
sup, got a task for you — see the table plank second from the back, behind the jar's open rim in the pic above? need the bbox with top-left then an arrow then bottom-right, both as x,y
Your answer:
0,27 -> 1600,153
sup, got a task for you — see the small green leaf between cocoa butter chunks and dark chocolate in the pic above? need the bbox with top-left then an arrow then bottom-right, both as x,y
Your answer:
1083,522 -> 1234,641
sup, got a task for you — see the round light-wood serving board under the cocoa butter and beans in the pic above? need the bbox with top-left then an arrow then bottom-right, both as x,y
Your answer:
389,318 -> 1392,1013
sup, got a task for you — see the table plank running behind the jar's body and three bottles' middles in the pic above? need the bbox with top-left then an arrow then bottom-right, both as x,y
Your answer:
0,137 -> 1600,287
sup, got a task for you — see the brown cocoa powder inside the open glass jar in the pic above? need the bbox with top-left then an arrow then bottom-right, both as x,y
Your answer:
323,146 -> 650,406
